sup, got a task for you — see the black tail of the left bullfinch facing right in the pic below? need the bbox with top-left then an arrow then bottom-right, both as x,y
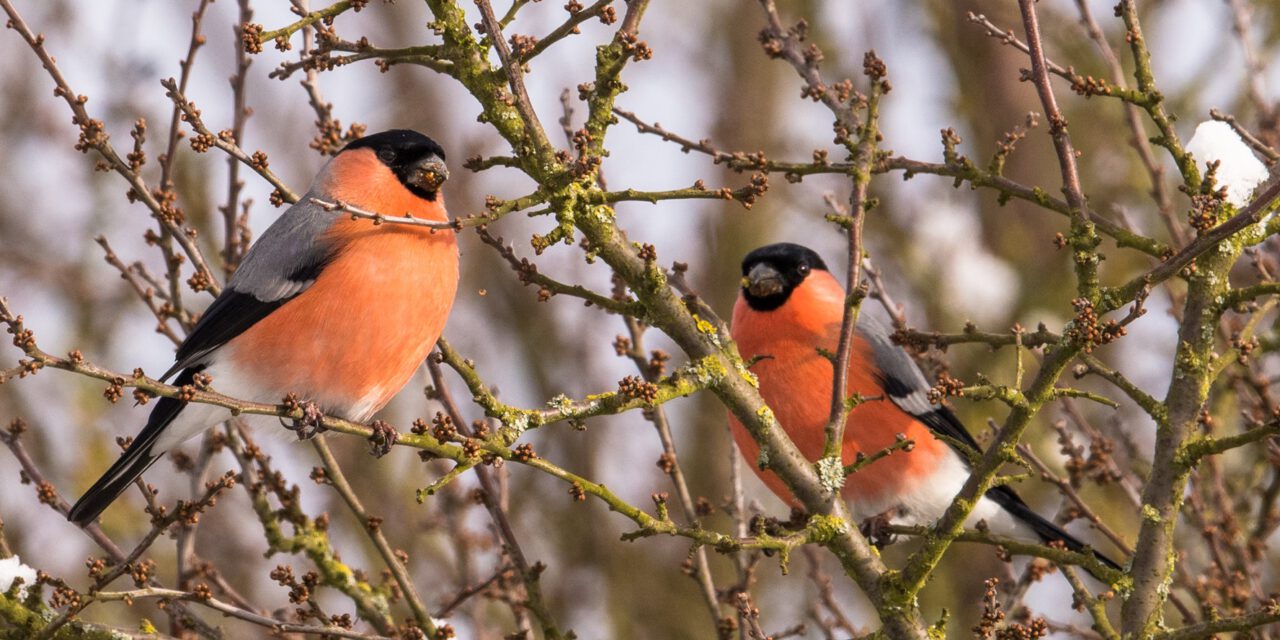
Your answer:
67,369 -> 198,526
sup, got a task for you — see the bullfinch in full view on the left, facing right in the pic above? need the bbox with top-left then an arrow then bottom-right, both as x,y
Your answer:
68,131 -> 458,526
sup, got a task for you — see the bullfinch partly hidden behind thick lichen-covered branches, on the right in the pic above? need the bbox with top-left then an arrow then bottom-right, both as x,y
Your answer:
730,243 -> 1120,568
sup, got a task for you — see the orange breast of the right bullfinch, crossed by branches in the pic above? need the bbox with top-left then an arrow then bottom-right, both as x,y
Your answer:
730,274 -> 947,504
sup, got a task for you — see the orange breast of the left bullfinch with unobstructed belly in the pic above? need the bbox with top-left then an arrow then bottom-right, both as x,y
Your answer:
229,179 -> 458,420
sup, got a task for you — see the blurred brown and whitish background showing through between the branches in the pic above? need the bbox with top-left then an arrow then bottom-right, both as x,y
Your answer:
0,0 -> 1280,639
